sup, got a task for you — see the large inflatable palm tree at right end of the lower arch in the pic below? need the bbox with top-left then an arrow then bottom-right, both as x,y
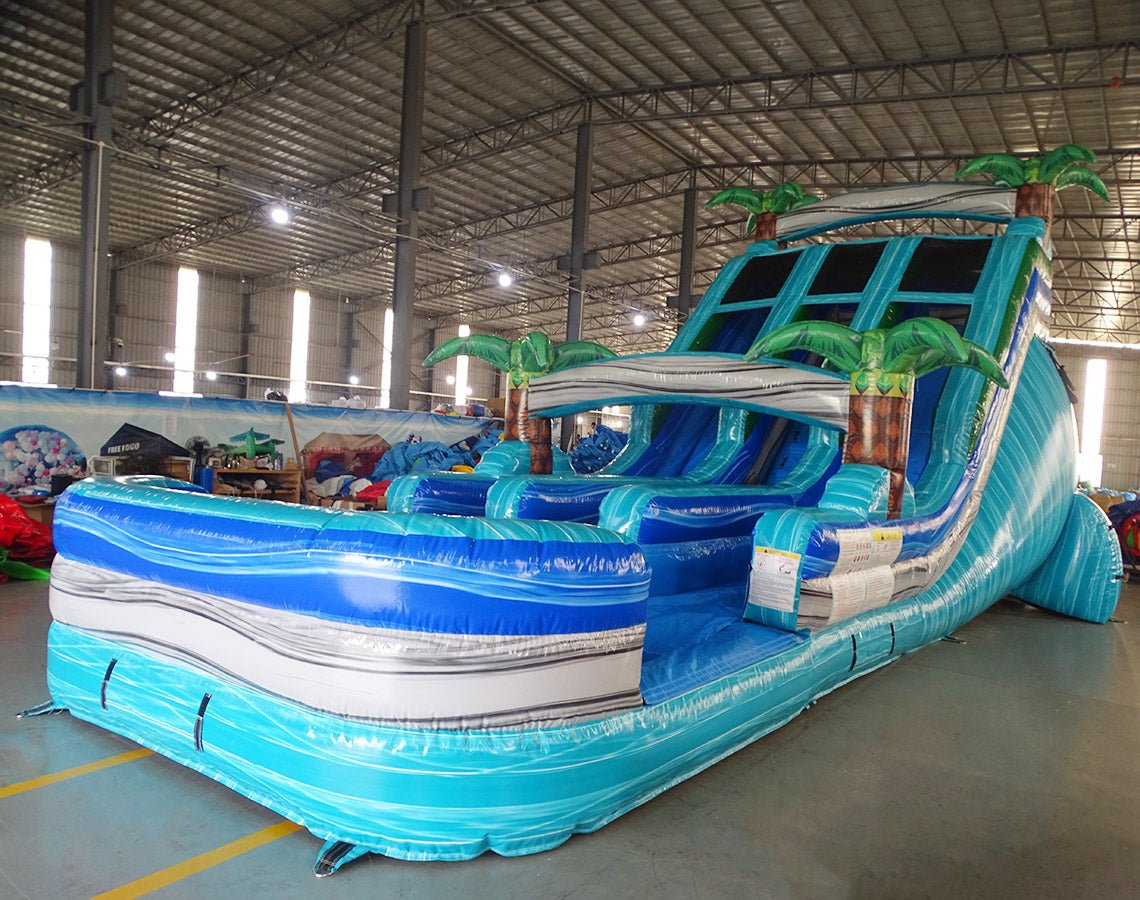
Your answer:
744,318 -> 1009,519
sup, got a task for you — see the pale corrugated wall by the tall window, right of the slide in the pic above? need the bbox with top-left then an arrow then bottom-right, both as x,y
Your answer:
1053,344 -> 1140,490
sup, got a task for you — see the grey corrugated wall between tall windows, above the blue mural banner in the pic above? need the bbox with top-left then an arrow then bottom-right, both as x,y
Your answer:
0,230 -> 446,408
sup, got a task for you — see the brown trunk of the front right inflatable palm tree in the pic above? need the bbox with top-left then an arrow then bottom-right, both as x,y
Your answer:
844,368 -> 914,519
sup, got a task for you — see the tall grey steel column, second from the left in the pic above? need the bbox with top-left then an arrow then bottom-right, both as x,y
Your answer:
391,22 -> 428,410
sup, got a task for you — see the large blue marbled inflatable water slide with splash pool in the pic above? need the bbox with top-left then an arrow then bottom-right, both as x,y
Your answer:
35,176 -> 1121,874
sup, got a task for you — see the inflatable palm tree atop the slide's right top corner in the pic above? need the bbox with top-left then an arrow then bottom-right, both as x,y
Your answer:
954,144 -> 1108,230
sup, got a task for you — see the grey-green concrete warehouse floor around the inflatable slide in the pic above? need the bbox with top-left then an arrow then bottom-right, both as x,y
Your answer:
0,583 -> 1140,900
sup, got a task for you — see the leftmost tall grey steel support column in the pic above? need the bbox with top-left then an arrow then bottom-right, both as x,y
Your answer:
72,0 -> 117,388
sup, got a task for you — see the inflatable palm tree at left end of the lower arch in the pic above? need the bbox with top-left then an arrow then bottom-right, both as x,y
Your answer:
424,331 -> 616,475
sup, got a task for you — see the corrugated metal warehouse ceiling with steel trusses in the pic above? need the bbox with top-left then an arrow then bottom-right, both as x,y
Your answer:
0,0 -> 1140,350
